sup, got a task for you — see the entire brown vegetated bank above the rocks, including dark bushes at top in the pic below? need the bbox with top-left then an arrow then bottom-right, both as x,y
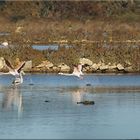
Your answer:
0,0 -> 140,72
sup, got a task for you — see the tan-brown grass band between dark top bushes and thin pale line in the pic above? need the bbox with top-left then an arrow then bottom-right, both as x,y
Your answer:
0,18 -> 140,44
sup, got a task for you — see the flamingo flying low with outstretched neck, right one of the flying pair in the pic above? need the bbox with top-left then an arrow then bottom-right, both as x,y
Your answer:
58,64 -> 84,79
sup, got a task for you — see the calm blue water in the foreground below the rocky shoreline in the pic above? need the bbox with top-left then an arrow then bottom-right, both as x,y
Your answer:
0,74 -> 140,139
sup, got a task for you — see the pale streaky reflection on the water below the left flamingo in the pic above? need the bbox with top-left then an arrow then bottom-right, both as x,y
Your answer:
2,86 -> 23,115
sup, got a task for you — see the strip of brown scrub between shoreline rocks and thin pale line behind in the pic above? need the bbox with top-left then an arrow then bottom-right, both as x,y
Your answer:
0,42 -> 140,72
